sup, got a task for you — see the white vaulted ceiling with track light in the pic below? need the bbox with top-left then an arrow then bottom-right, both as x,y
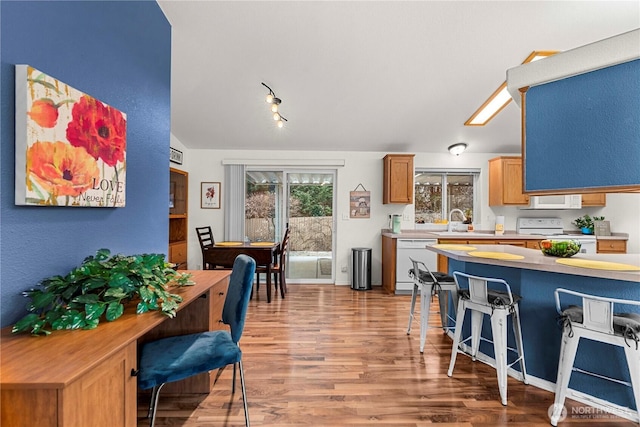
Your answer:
158,0 -> 640,153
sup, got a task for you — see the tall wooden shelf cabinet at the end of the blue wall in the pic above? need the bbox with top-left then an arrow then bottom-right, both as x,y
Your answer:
167,168 -> 189,270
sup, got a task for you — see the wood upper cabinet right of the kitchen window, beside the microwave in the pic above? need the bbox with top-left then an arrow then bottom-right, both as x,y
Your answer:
489,156 -> 529,206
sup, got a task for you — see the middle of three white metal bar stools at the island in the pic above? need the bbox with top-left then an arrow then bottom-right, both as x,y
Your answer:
447,271 -> 528,405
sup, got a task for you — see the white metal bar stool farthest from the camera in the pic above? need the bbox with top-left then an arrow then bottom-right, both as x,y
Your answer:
407,257 -> 458,353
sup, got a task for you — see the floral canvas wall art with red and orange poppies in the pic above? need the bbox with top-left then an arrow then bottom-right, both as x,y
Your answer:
15,65 -> 127,207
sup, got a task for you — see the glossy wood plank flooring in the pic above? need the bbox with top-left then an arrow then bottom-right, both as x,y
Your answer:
138,285 -> 637,427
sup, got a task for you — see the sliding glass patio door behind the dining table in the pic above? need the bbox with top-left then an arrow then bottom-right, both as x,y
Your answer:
245,168 -> 336,284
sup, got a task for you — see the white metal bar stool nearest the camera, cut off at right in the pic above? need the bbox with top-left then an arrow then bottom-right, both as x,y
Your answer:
551,288 -> 640,426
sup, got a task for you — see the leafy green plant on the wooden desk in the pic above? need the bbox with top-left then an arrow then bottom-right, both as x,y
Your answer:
12,249 -> 193,335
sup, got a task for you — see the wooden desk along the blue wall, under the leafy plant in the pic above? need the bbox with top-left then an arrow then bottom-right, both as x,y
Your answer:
0,270 -> 231,427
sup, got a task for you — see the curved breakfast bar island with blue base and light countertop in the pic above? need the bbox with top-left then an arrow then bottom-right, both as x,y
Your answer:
427,244 -> 640,422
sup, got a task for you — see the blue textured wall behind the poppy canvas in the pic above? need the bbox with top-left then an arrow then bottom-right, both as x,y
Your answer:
0,0 -> 171,327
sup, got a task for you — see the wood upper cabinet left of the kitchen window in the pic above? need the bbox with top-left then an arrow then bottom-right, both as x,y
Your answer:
382,154 -> 414,205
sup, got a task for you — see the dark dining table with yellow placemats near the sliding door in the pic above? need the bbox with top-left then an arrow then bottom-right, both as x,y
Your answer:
203,241 -> 280,303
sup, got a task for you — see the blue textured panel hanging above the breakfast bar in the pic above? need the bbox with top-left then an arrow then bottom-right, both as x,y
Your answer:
524,60 -> 640,191
